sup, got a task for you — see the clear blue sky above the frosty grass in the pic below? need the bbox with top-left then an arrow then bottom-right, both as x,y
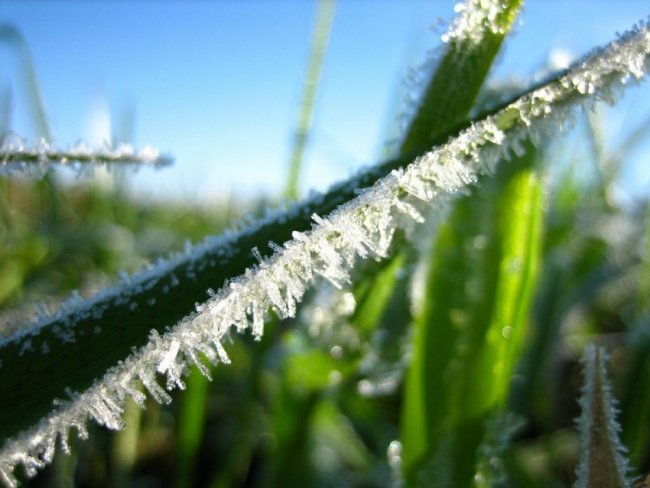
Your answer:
0,0 -> 650,200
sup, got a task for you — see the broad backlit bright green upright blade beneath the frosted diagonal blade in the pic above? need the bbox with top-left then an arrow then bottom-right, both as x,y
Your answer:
402,147 -> 542,486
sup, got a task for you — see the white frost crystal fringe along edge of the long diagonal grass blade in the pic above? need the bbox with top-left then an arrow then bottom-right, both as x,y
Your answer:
0,17 -> 650,486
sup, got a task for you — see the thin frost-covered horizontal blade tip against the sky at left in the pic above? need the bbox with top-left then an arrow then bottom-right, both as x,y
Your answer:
0,134 -> 172,176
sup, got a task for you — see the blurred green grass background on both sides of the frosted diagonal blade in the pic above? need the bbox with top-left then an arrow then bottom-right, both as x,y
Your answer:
0,2 -> 650,487
